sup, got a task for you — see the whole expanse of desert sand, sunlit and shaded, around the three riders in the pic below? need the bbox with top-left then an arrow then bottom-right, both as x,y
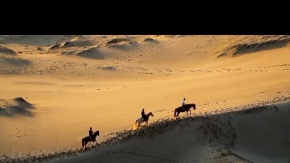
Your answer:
0,35 -> 290,162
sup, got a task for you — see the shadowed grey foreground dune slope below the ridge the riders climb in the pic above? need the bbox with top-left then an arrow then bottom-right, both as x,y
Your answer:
1,103 -> 290,162
